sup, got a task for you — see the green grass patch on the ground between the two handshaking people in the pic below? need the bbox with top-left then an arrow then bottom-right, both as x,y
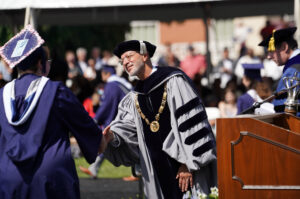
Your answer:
74,158 -> 131,178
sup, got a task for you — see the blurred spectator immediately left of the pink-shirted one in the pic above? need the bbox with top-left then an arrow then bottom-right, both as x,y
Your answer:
158,43 -> 180,67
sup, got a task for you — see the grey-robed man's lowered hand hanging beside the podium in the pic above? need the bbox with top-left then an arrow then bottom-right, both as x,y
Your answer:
176,164 -> 193,192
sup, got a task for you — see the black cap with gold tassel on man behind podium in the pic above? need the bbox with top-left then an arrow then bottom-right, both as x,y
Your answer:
258,27 -> 297,52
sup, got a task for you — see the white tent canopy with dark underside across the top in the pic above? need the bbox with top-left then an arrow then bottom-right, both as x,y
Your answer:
0,0 -> 300,25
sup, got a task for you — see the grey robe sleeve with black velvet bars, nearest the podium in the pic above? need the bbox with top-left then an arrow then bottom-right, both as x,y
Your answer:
163,76 -> 216,171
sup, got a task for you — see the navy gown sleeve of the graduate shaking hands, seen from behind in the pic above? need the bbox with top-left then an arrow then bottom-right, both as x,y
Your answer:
55,86 -> 102,163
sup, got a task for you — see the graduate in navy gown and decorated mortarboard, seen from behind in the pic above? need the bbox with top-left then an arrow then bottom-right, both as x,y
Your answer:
0,25 -> 104,199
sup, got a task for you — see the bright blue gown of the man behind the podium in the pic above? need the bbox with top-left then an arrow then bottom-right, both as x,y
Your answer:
273,49 -> 300,117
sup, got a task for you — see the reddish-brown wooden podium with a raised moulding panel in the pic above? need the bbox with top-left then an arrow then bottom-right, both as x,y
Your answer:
216,113 -> 300,199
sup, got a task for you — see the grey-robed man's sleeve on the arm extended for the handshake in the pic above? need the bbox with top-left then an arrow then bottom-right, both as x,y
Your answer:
104,93 -> 139,166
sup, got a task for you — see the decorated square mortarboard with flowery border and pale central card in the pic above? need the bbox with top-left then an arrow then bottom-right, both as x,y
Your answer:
0,25 -> 45,68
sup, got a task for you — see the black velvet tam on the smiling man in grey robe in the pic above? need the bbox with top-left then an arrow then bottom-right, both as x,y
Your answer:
114,40 -> 156,58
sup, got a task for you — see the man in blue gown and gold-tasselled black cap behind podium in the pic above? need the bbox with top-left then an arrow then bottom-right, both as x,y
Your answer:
258,27 -> 300,117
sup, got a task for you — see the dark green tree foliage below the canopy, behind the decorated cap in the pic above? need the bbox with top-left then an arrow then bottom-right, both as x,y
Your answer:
0,24 -> 129,58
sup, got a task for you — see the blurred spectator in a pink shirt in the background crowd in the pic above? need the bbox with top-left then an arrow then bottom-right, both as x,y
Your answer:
180,45 -> 206,80
